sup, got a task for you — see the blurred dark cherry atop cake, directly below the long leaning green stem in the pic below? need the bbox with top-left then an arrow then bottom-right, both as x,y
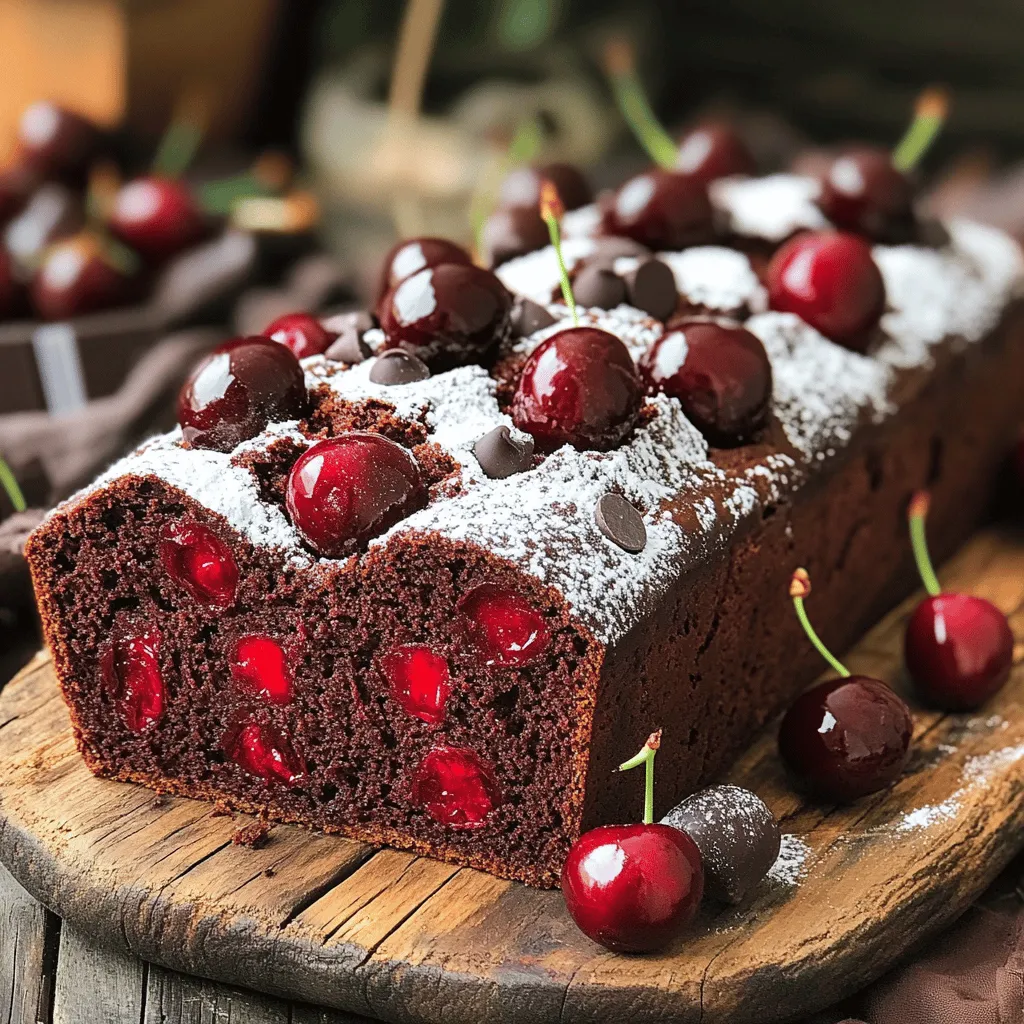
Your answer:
601,167 -> 714,250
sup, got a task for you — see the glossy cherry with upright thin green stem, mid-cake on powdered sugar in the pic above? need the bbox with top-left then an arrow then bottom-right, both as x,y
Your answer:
512,327 -> 643,452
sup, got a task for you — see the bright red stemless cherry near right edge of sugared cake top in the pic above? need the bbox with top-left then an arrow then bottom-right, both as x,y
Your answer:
766,231 -> 886,352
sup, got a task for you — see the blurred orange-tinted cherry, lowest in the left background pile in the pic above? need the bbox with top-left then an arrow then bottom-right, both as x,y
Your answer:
30,234 -> 132,321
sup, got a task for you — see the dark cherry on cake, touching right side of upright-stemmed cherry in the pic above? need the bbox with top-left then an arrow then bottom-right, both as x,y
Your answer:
640,319 -> 771,447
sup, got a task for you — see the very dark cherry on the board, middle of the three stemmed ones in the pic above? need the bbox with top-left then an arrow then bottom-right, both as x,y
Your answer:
778,676 -> 913,803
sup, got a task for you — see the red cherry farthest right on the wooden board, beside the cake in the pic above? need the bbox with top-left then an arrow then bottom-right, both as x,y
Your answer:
903,594 -> 1014,711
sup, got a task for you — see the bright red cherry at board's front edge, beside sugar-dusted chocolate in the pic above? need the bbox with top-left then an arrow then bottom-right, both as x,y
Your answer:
562,824 -> 703,953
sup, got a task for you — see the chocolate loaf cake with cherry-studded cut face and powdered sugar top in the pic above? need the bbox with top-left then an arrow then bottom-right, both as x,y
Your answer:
28,177 -> 1024,886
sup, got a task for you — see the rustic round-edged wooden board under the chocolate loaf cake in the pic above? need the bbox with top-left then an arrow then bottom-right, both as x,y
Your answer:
0,532 -> 1024,1024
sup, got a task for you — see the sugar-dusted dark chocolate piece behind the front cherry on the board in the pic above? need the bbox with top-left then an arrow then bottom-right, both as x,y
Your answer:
662,785 -> 781,903
